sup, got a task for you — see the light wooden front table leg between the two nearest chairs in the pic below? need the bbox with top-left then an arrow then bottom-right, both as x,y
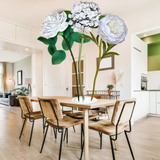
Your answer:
84,109 -> 89,160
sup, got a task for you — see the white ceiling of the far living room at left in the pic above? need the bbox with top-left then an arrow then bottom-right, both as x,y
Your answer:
0,50 -> 30,63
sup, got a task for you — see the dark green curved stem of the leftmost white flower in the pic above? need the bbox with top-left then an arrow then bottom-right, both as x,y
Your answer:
63,36 -> 79,101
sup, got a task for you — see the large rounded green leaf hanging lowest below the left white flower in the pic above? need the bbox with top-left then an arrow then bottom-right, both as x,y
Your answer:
52,50 -> 66,65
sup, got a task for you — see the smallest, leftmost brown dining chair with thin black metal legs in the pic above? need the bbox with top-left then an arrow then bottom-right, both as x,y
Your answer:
18,96 -> 44,146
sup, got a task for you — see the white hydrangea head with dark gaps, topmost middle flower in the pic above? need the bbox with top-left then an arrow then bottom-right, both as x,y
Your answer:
69,2 -> 101,33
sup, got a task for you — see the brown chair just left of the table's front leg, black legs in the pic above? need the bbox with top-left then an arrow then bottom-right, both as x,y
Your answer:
39,97 -> 83,160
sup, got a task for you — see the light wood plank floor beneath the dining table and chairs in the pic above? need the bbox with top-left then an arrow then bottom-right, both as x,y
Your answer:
0,105 -> 160,160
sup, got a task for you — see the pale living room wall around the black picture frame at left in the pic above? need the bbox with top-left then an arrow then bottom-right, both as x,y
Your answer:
13,56 -> 32,88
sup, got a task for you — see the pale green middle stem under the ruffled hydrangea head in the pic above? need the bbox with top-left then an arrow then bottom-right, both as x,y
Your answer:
78,38 -> 84,101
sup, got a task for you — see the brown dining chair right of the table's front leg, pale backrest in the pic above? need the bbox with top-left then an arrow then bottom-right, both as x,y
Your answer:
80,99 -> 136,160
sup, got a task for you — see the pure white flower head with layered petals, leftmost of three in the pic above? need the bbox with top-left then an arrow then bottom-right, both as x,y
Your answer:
41,12 -> 68,38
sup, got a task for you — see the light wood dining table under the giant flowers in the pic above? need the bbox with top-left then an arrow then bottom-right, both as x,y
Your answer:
27,96 -> 116,160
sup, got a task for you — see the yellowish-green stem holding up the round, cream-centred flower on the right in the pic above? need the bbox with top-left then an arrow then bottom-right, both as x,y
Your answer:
91,39 -> 102,101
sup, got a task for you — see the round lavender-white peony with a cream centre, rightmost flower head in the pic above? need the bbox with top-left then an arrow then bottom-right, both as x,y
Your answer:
98,14 -> 128,44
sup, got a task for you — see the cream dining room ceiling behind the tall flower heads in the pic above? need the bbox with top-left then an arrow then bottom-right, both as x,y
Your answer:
0,0 -> 156,31
